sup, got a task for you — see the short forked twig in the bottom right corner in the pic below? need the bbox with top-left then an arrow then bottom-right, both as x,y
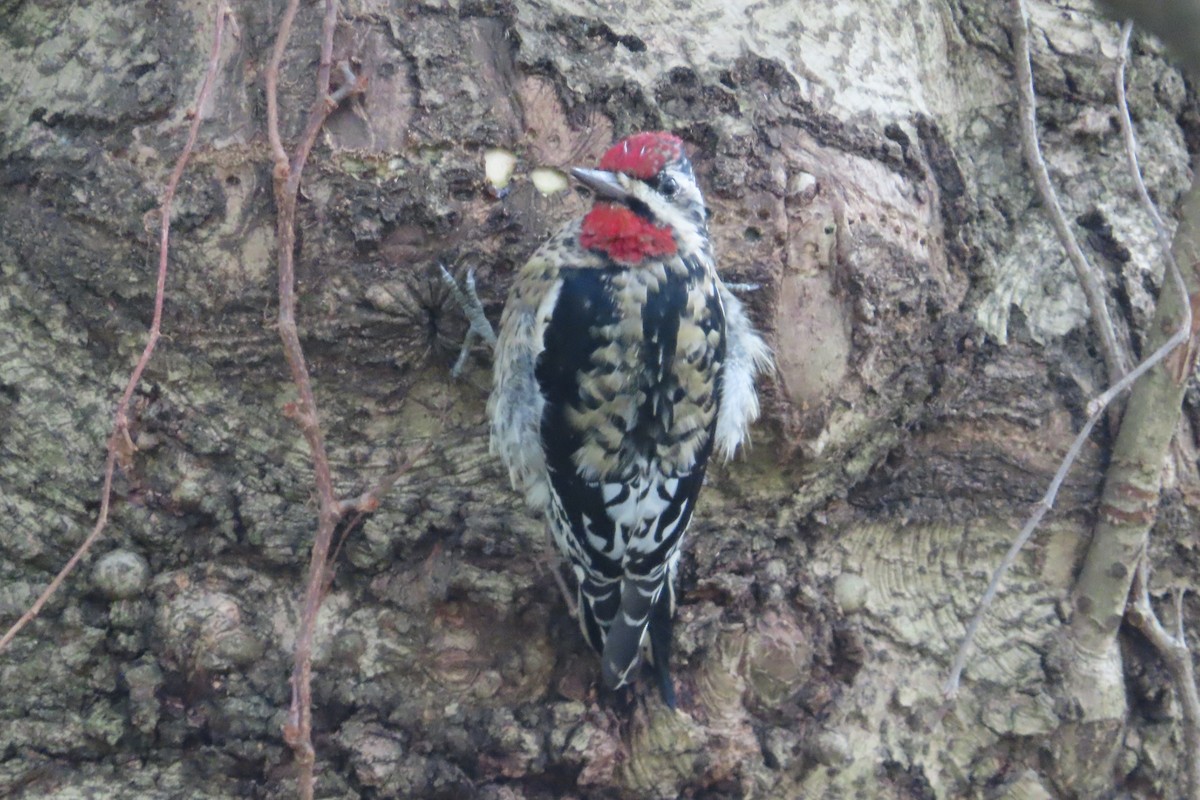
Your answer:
1126,557 -> 1200,800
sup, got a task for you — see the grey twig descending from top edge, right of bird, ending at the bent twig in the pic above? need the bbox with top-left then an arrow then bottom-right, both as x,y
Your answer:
1012,0 -> 1129,384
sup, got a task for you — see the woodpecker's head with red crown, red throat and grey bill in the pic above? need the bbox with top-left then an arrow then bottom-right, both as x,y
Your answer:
571,131 -> 708,265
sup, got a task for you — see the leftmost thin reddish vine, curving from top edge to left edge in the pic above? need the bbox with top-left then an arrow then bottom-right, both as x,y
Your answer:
0,1 -> 233,652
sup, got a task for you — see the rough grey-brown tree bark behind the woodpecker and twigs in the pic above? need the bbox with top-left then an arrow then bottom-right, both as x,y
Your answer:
0,0 -> 1200,799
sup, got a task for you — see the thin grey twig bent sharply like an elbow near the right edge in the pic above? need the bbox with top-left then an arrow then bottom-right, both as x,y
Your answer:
944,15 -> 1192,698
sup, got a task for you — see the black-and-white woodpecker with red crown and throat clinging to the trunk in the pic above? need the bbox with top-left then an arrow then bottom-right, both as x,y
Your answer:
488,132 -> 770,708
